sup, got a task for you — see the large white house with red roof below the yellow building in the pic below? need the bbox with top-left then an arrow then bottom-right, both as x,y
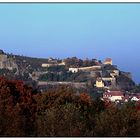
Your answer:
103,91 -> 124,102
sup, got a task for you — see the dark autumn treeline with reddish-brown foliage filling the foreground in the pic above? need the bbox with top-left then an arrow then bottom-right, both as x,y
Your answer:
0,77 -> 140,137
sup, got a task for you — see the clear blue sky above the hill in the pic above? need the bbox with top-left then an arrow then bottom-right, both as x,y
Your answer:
0,3 -> 140,83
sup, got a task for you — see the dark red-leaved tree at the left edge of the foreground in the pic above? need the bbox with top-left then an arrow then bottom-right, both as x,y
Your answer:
0,77 -> 36,136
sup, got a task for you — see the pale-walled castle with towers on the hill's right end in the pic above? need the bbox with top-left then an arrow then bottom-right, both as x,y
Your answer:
66,58 -> 120,88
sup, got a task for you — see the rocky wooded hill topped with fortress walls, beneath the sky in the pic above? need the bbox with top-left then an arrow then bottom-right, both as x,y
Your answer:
0,50 -> 135,90
